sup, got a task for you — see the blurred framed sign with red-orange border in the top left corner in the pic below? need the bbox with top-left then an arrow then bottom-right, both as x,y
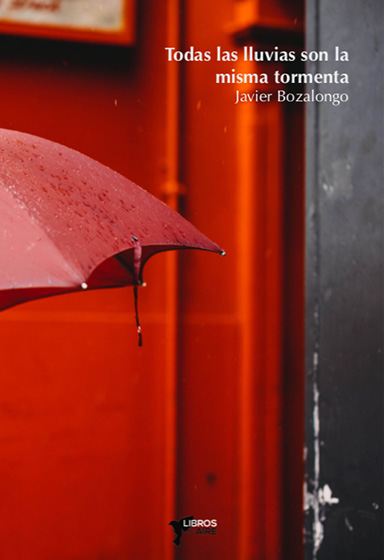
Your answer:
0,0 -> 135,45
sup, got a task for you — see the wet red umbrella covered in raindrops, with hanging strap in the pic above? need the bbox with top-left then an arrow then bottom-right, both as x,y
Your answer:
0,129 -> 224,344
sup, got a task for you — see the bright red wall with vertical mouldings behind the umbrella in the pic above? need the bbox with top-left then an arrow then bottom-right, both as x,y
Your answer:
0,0 -> 302,560
